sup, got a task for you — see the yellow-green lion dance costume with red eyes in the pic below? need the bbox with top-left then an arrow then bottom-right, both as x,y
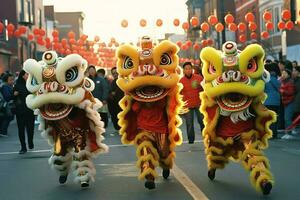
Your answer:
200,41 -> 276,194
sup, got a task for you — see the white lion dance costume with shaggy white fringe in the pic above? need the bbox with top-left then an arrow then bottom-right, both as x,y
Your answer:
24,51 -> 108,187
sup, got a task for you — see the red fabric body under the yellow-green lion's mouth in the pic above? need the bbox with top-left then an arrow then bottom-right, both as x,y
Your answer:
216,116 -> 254,138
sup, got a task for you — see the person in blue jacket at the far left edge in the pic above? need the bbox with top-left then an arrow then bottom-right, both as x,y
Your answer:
0,73 -> 14,137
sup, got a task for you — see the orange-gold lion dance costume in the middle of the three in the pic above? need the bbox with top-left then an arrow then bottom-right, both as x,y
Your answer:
117,37 -> 183,189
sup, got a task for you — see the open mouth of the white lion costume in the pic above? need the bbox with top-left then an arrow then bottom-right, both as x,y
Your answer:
40,103 -> 73,121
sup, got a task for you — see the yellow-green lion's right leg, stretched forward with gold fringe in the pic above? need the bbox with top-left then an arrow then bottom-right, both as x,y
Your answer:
242,140 -> 274,195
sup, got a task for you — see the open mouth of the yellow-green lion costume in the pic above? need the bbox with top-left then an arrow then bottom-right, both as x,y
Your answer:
216,93 -> 253,112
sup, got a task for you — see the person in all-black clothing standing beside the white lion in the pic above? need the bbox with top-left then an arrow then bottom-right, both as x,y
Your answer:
14,70 -> 35,154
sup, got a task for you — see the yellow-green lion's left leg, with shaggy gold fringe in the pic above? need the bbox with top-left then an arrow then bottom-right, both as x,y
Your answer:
205,136 -> 233,180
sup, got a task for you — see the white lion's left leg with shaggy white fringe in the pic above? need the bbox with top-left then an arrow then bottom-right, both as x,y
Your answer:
49,134 -> 72,184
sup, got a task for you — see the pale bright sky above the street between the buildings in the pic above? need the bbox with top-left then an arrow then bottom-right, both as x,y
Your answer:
44,0 -> 187,42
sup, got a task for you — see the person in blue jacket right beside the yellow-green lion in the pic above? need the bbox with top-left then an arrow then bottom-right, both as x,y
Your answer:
264,62 -> 280,138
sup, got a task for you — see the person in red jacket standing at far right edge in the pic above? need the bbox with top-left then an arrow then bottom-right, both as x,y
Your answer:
280,67 -> 295,139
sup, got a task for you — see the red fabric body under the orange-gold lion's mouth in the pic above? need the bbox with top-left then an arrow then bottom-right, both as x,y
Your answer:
132,98 -> 168,134
